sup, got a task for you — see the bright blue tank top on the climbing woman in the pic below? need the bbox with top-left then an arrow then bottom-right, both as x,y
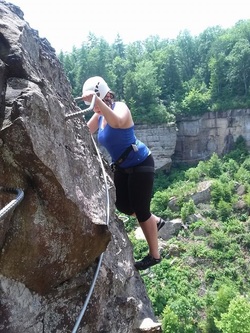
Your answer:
97,116 -> 150,168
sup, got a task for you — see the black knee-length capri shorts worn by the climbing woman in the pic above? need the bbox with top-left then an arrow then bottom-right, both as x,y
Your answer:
114,155 -> 155,222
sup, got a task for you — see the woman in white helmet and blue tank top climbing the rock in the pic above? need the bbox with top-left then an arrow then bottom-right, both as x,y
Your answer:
82,76 -> 165,270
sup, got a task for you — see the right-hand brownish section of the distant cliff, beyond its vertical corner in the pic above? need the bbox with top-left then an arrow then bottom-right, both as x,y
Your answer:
172,109 -> 250,164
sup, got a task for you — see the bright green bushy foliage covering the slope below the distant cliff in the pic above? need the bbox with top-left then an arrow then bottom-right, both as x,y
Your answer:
129,148 -> 250,333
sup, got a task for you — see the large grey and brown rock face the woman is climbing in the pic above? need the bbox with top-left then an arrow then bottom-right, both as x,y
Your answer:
0,0 -> 160,333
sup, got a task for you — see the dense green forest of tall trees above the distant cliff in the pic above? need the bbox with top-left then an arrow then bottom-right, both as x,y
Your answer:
58,20 -> 250,123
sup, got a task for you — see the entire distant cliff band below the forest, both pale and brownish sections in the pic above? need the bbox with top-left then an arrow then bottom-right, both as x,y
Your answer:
135,109 -> 250,171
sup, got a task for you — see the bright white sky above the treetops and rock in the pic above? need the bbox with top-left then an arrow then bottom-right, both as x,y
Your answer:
6,0 -> 250,52
